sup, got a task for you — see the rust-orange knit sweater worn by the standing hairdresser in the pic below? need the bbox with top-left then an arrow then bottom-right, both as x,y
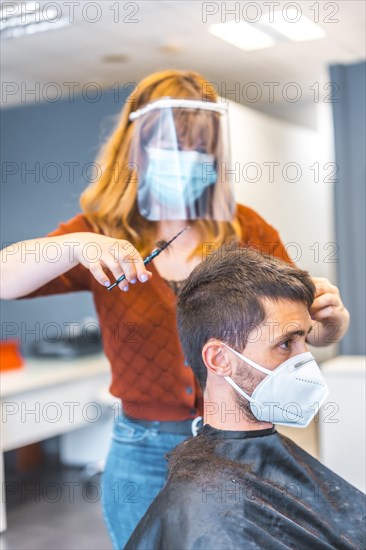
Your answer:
22,205 -> 291,420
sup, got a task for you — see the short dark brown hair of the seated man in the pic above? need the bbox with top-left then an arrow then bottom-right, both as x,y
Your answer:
177,243 -> 315,390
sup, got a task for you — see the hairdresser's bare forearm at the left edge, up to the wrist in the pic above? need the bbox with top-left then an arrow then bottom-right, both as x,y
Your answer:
0,233 -> 85,300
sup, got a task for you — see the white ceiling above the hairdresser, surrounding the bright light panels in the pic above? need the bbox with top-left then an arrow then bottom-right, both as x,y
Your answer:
1,0 -> 366,124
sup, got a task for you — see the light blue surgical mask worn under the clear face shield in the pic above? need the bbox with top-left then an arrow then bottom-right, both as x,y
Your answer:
144,148 -> 217,209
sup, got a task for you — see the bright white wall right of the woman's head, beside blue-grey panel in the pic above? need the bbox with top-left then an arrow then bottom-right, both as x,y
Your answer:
229,98 -> 335,280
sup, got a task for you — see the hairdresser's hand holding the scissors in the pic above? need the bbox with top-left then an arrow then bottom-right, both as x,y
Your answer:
74,232 -> 152,290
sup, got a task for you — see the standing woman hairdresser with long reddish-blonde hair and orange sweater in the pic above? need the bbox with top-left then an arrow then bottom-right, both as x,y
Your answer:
1,70 -> 348,548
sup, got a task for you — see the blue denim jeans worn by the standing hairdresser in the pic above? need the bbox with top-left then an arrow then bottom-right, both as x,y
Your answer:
101,415 -> 187,549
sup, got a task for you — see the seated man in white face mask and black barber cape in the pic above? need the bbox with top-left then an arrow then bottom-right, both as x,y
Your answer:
126,246 -> 365,550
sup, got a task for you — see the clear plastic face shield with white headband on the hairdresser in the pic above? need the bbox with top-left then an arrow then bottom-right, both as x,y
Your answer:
130,98 -> 235,222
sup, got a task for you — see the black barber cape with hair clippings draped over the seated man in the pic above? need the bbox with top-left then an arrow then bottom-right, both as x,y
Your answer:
125,424 -> 365,550
